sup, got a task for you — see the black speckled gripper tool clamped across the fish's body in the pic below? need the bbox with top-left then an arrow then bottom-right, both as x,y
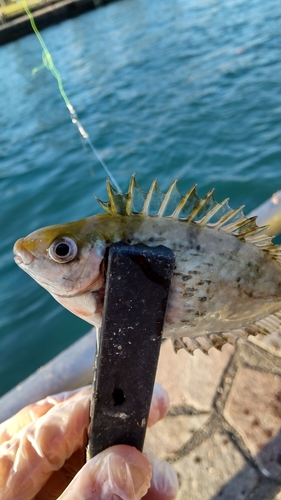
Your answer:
87,243 -> 174,458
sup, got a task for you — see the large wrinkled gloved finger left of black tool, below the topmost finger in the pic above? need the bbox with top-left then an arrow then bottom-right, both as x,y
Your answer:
0,391 -> 89,500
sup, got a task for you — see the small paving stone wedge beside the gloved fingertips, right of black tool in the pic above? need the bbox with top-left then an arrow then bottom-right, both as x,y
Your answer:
145,414 -> 208,458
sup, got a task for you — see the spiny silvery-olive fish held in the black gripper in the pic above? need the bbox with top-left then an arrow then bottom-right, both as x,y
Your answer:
14,175 -> 281,354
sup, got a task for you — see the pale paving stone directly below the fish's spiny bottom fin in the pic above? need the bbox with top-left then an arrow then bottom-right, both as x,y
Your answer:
156,341 -> 235,411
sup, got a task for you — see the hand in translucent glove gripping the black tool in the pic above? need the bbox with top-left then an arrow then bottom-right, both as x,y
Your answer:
0,384 -> 178,500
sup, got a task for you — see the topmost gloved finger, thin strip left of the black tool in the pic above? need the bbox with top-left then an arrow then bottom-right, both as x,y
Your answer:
0,386 -> 91,444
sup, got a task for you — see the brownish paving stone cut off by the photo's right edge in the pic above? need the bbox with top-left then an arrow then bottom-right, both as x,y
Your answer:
224,367 -> 281,479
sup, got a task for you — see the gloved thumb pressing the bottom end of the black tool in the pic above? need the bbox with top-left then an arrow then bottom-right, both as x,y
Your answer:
58,445 -> 151,500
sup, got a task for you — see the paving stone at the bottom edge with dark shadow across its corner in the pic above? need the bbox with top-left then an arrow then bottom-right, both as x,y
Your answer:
173,432 -> 259,500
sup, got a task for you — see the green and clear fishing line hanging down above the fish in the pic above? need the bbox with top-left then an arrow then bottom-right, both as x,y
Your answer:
21,0 -> 121,193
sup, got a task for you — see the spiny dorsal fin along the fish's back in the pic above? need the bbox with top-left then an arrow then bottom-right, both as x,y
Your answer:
97,175 -> 281,264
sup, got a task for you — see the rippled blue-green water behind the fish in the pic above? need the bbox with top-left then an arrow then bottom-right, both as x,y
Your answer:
0,0 -> 281,393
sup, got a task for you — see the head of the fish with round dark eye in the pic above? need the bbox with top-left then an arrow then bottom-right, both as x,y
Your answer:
14,218 -> 106,309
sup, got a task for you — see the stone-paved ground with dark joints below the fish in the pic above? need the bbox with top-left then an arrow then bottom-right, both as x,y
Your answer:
146,334 -> 281,500
